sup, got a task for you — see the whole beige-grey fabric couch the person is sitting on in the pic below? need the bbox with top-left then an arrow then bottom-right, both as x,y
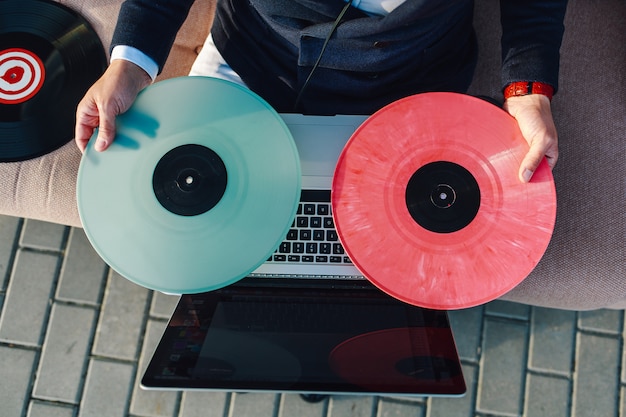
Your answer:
0,0 -> 626,310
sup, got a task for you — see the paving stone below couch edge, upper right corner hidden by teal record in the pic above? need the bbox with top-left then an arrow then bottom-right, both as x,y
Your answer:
56,228 -> 107,306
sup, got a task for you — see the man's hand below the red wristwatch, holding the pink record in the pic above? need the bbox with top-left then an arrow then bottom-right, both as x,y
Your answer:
504,94 -> 559,182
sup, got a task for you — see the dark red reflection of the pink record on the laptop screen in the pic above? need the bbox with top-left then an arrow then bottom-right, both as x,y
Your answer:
329,327 -> 465,394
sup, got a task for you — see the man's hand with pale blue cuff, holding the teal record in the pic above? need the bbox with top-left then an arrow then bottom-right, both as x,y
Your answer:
75,60 -> 152,152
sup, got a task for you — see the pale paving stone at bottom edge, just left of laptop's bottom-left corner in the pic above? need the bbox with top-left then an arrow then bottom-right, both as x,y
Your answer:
78,359 -> 135,417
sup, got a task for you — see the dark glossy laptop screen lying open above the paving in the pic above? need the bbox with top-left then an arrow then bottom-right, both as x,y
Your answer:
142,279 -> 465,395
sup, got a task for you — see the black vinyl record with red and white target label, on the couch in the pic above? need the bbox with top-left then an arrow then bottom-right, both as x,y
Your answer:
0,0 -> 107,162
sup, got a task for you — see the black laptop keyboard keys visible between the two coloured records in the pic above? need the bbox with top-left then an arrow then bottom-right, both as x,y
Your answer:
268,190 -> 352,265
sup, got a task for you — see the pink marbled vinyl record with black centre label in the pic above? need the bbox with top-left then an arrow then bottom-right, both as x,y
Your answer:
332,93 -> 556,309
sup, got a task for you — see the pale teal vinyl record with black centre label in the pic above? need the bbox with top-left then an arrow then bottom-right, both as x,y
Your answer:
77,77 -> 301,294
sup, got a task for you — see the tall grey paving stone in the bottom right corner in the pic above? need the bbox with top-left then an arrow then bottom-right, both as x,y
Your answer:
572,332 -> 621,417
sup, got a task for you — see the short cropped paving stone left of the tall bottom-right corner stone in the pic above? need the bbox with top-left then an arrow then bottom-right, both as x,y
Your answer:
524,374 -> 571,417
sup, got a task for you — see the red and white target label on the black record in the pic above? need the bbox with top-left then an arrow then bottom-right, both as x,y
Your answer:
0,48 -> 45,104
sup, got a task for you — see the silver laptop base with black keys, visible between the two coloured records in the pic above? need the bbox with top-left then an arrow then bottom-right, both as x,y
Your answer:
251,114 -> 367,279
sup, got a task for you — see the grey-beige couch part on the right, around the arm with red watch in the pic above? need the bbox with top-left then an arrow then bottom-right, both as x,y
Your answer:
472,0 -> 626,310
